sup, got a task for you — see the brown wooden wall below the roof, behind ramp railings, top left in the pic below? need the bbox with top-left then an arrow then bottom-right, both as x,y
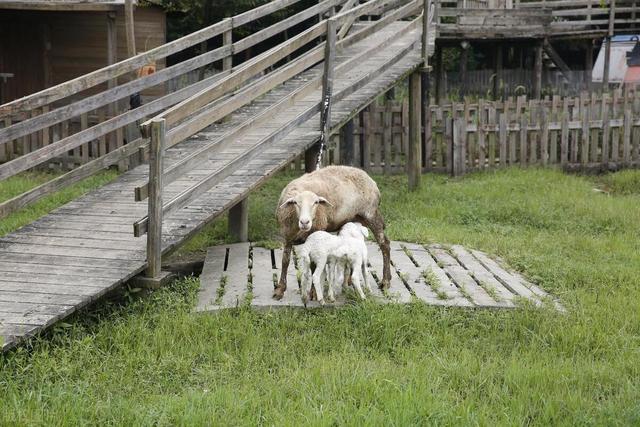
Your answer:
0,7 -> 166,102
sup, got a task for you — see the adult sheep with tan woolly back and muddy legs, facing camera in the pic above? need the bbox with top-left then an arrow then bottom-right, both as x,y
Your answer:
273,166 -> 391,299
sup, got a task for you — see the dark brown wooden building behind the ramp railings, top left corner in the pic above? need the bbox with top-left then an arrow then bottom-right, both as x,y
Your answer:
0,0 -> 166,104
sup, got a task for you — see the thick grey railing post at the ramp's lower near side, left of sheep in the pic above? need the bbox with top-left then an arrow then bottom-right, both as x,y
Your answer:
146,119 -> 165,279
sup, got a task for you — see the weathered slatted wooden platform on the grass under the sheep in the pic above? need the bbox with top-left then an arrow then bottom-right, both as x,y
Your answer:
196,242 -> 564,311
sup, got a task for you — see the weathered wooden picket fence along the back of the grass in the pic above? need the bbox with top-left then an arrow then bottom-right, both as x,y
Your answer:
326,88 -> 640,175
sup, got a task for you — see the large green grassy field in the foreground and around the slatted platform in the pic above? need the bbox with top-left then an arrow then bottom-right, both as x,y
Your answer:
0,169 -> 640,426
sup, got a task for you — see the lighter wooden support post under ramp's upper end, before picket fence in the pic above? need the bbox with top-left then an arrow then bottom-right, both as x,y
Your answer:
407,71 -> 422,190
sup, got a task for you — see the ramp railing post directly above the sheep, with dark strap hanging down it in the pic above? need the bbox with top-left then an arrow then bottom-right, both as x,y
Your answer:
305,18 -> 338,172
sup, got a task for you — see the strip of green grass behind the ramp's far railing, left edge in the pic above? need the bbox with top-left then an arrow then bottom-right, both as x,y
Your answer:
0,170 -> 118,236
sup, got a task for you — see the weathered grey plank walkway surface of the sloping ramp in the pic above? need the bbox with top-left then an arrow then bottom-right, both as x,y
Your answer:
0,21 -> 421,349
